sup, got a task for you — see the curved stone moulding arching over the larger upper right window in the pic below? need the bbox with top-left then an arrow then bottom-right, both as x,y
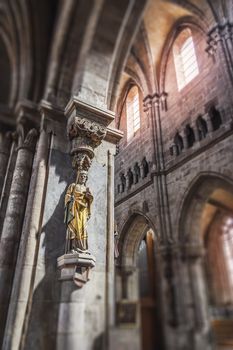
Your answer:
158,16 -> 208,92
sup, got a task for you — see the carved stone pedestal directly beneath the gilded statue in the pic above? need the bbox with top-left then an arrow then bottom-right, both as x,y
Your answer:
57,253 -> 96,288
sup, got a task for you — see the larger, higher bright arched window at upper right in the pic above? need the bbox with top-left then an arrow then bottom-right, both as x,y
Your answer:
173,28 -> 199,91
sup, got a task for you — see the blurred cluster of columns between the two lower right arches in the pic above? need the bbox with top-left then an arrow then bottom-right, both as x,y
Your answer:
156,242 -> 213,350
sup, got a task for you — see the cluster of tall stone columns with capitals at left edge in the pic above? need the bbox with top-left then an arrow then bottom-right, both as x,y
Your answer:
0,101 -> 52,349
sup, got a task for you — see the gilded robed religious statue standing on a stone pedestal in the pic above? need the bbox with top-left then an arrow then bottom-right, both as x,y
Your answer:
64,170 -> 93,254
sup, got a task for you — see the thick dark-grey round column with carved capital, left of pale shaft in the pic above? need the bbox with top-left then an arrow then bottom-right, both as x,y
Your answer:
0,124 -> 37,341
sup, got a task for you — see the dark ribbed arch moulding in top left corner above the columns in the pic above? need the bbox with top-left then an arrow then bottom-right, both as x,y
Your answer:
0,1 -> 33,108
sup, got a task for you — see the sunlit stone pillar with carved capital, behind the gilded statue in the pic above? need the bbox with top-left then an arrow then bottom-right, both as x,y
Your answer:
57,99 -> 119,350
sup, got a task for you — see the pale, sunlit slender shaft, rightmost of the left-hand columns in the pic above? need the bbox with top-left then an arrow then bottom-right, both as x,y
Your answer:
3,129 -> 49,350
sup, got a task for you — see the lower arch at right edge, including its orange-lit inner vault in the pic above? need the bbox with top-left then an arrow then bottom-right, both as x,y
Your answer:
178,172 -> 233,244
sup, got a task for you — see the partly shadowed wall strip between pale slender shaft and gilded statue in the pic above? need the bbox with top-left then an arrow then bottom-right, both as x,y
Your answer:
24,150 -> 74,350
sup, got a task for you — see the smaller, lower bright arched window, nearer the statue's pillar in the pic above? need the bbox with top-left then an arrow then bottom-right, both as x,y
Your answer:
126,85 -> 140,140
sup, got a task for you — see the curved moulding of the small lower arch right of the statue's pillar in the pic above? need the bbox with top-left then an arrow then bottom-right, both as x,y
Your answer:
119,211 -> 158,267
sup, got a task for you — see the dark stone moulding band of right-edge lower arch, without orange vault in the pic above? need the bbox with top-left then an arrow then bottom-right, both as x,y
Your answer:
177,172 -> 233,243
